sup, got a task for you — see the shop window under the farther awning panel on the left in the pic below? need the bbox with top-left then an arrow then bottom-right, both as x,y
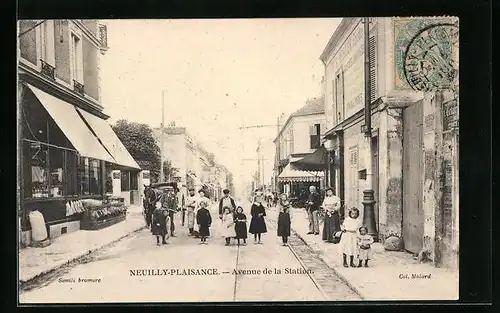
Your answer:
78,157 -> 102,195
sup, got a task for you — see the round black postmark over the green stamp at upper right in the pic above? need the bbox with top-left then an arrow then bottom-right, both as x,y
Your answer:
403,24 -> 458,91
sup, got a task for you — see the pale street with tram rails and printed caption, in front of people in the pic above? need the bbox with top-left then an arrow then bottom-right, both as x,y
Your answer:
20,197 -> 356,303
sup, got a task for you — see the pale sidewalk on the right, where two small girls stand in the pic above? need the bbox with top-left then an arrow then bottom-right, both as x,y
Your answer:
268,208 -> 459,301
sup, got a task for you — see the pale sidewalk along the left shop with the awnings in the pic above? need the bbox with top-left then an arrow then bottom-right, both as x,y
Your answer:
19,205 -> 145,284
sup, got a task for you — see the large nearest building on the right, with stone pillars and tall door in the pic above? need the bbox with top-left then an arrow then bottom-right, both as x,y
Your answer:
320,18 -> 458,267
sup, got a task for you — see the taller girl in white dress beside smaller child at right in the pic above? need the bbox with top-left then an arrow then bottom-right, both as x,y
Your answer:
339,208 -> 361,267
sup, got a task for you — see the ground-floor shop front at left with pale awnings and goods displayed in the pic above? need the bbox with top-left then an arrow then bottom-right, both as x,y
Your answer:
18,83 -> 140,245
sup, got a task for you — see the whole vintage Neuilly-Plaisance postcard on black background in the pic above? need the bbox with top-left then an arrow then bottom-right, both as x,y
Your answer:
17,16 -> 459,305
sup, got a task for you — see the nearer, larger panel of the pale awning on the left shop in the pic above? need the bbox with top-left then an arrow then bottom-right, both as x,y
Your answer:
28,84 -> 116,163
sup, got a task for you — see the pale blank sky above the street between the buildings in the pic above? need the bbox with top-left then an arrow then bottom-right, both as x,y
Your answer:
100,18 -> 340,191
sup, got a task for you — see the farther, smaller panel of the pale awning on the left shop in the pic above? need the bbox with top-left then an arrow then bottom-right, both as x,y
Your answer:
77,108 -> 141,169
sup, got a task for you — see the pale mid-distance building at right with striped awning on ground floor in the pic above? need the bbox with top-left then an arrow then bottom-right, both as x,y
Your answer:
273,97 -> 326,197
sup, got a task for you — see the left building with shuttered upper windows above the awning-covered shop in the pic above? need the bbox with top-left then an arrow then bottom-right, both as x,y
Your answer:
17,20 -> 140,245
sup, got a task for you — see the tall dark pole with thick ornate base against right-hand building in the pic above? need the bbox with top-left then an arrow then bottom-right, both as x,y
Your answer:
363,17 -> 378,241
